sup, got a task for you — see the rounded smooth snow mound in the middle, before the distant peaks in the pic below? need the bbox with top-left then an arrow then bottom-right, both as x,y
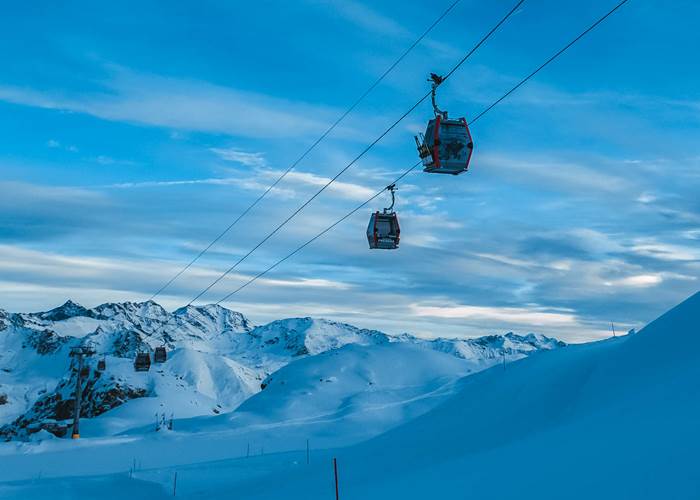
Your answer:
164,342 -> 471,450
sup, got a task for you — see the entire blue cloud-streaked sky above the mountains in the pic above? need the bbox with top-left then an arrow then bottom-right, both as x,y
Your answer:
0,0 -> 700,341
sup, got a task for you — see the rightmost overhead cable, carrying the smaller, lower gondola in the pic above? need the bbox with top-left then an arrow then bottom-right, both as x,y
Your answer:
216,0 -> 628,304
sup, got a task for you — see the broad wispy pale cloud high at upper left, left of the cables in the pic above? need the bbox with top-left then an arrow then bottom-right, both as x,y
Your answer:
0,65 -> 348,137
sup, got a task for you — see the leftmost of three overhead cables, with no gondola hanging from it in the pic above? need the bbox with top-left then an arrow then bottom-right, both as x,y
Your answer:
150,0 -> 462,300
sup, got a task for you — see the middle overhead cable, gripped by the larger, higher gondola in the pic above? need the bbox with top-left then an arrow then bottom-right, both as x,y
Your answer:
187,0 -> 525,305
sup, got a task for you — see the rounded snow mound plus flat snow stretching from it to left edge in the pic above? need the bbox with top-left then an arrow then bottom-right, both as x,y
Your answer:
0,342 -> 482,484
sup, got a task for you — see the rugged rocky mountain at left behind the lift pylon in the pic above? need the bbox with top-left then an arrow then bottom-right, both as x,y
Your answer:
0,301 -> 262,438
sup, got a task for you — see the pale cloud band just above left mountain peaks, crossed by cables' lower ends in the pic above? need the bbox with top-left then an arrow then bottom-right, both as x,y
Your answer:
0,245 -> 351,310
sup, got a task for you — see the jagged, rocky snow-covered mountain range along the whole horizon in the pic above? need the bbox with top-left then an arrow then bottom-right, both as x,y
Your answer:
0,301 -> 564,439
